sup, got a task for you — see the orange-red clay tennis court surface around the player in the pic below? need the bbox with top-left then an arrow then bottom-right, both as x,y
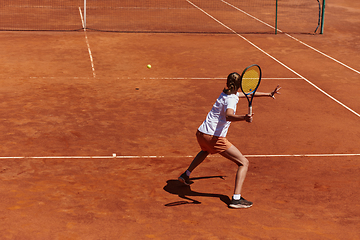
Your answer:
0,0 -> 360,240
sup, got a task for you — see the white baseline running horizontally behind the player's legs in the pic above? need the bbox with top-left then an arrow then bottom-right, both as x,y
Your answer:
0,153 -> 360,160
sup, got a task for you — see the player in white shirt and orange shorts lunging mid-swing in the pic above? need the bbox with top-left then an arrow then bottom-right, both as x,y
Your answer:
179,72 -> 280,208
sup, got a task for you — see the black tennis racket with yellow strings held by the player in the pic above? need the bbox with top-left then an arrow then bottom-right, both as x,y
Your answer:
240,64 -> 261,122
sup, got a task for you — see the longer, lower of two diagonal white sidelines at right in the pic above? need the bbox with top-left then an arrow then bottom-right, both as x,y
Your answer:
186,0 -> 360,117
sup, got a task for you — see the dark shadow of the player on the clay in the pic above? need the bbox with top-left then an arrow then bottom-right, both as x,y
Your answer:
164,176 -> 231,207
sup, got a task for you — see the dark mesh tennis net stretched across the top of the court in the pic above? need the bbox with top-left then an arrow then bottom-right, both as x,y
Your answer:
0,0 -> 320,33
